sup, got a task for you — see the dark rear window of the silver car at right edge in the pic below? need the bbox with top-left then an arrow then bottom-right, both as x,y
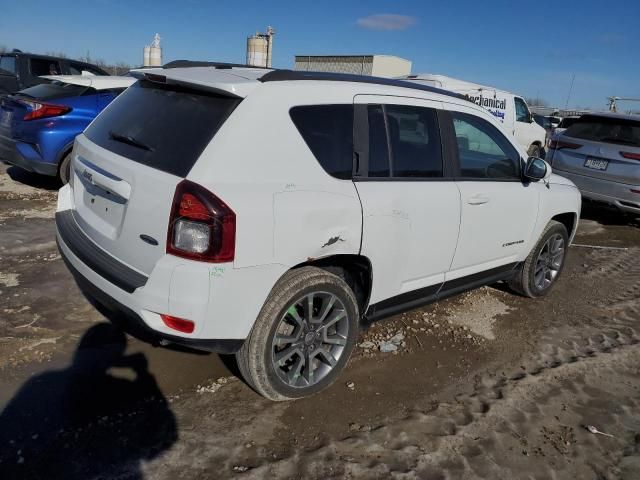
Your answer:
564,115 -> 640,147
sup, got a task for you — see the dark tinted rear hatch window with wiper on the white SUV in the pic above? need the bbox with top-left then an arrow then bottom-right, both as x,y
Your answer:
84,80 -> 240,177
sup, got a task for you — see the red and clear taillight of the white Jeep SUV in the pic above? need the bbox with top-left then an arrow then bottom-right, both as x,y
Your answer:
167,180 -> 236,263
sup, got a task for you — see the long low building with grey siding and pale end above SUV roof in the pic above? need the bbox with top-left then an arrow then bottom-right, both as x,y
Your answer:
293,55 -> 411,77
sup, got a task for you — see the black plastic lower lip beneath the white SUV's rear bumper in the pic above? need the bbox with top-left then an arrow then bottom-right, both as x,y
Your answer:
62,255 -> 244,354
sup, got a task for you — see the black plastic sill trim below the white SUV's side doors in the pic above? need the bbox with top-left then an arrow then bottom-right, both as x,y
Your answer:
365,262 -> 521,323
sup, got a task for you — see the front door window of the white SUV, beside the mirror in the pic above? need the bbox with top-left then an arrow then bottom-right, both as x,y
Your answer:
451,112 -> 520,180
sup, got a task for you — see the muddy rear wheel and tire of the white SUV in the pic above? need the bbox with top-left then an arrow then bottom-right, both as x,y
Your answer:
236,267 -> 360,401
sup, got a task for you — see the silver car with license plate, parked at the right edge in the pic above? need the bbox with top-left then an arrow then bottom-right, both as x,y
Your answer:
549,113 -> 640,213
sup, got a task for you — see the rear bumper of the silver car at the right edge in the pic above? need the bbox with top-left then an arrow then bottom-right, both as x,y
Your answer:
554,169 -> 640,213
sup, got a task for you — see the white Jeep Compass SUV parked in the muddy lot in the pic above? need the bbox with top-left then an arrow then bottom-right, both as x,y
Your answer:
56,62 -> 580,400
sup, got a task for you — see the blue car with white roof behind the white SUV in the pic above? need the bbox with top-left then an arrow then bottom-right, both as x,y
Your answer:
0,75 -> 135,183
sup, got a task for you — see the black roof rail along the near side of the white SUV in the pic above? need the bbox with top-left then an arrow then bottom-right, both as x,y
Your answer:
258,70 -> 466,100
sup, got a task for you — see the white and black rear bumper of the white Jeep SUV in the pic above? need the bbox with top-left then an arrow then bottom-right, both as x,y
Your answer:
56,185 -> 285,353
